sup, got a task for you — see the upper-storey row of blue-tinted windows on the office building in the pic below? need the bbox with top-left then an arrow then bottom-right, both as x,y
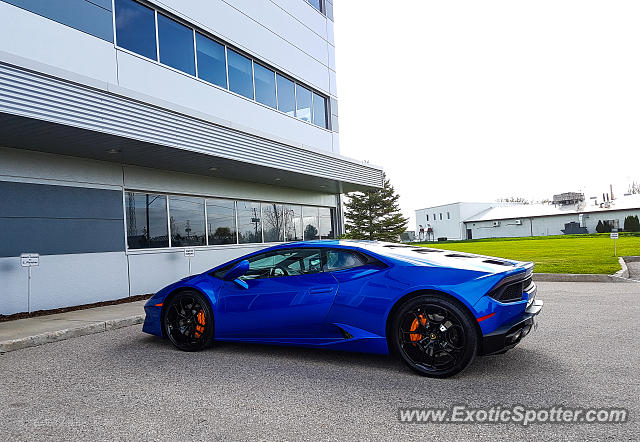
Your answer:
115,0 -> 329,129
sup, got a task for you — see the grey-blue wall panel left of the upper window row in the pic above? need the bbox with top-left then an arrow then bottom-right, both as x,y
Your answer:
0,0 -> 113,43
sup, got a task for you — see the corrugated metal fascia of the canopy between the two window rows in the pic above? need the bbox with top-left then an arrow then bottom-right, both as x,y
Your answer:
0,63 -> 383,187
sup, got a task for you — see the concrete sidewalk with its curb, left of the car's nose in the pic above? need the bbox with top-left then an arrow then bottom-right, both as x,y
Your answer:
0,301 -> 146,352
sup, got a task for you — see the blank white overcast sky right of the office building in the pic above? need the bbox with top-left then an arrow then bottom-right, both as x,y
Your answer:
335,0 -> 640,230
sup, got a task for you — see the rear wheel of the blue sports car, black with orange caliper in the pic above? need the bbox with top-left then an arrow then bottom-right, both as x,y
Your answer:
390,294 -> 478,378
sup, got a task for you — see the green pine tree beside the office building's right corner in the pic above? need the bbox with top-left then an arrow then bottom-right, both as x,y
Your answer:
345,177 -> 408,242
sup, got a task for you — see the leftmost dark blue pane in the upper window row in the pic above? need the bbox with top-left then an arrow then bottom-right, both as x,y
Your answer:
115,0 -> 157,60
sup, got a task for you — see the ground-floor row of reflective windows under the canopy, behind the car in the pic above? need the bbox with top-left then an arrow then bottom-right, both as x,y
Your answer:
125,191 -> 337,249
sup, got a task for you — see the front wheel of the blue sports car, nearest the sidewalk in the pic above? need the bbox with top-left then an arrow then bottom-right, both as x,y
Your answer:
162,290 -> 214,351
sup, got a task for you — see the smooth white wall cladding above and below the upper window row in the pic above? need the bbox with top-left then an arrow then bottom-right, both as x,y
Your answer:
0,0 -> 339,153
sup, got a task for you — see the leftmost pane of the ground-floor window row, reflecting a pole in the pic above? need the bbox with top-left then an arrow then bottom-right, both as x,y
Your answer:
125,192 -> 169,249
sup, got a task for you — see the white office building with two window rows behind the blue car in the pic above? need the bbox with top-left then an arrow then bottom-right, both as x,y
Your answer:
0,0 -> 383,315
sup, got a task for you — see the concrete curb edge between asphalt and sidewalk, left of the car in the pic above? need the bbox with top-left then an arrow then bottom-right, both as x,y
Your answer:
0,315 -> 144,353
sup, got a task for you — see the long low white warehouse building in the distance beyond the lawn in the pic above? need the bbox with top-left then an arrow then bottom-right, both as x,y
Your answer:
416,195 -> 640,240
